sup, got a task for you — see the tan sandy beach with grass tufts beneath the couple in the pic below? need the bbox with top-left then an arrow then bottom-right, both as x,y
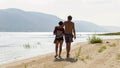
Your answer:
0,39 -> 120,68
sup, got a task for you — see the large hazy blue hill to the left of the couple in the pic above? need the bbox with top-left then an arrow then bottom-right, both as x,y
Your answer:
0,9 -> 61,32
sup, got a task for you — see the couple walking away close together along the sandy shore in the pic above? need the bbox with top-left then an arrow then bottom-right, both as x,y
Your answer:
53,16 -> 76,58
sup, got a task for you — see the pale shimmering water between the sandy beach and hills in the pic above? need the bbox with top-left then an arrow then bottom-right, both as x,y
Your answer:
0,32 -> 120,64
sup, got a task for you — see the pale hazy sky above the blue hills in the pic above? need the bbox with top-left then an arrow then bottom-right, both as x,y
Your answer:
0,0 -> 120,26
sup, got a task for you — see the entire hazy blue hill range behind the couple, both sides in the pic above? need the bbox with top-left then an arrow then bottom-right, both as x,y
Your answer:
0,8 -> 120,32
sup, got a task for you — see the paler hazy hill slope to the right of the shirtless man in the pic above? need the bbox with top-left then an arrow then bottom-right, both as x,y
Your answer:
74,21 -> 108,32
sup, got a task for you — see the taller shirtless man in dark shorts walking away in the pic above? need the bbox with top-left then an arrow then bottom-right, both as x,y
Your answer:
63,16 -> 76,58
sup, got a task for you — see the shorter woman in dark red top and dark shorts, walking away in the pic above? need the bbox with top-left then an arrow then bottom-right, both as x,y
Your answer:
53,21 -> 64,58
